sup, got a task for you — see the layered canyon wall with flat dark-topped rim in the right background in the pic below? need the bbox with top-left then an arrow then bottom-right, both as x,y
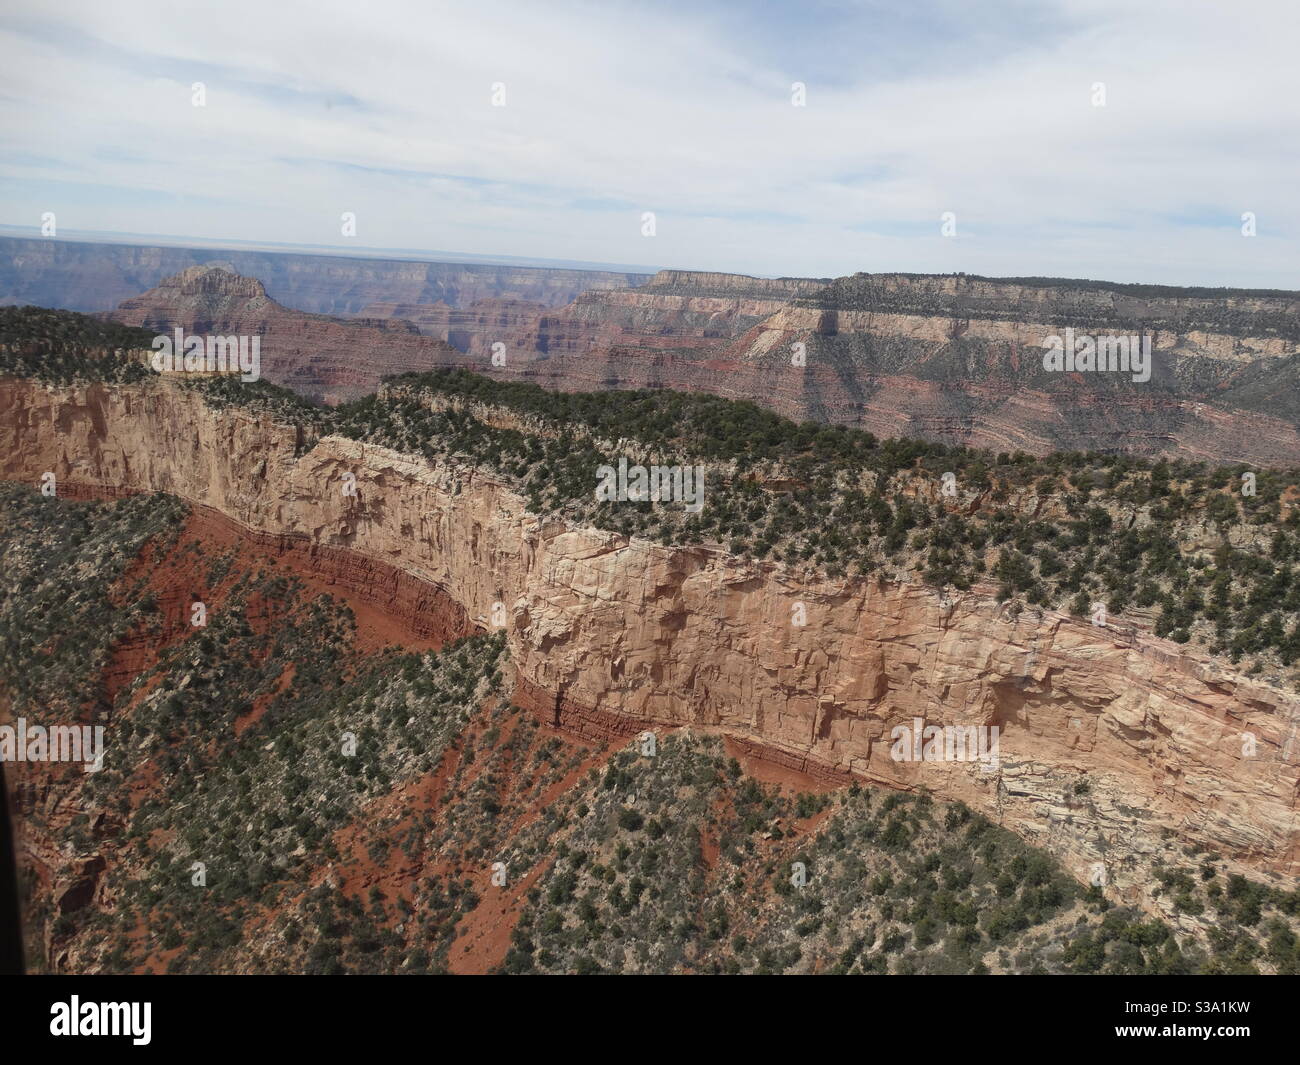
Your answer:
418,270 -> 1300,466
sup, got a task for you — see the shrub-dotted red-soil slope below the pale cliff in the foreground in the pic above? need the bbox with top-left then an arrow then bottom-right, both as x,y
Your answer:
0,486 -> 1300,974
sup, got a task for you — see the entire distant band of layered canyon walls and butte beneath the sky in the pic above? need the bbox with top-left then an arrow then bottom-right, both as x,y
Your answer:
0,238 -> 1300,466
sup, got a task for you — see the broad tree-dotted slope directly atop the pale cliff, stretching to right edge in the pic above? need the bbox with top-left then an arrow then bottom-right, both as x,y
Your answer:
7,315 -> 1300,685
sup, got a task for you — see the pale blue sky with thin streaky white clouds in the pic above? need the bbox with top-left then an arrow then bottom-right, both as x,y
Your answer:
0,0 -> 1300,289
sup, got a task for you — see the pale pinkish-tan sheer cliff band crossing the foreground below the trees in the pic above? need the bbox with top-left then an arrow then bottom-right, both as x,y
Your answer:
0,380 -> 1300,904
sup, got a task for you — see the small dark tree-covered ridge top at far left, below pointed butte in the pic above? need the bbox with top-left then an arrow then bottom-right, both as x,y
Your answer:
0,307 -> 155,385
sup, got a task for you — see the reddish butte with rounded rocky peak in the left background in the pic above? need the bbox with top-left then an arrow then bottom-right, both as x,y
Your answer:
112,264 -> 473,403
